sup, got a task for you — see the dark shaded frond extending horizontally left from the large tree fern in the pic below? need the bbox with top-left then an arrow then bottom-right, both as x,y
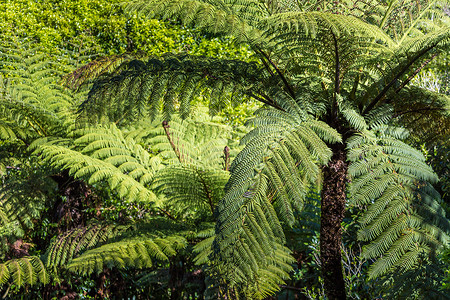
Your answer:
70,54 -> 264,121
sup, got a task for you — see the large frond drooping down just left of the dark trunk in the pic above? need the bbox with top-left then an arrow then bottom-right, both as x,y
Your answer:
214,97 -> 340,298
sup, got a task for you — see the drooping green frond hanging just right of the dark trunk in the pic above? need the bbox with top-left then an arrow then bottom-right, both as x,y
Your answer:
348,127 -> 450,277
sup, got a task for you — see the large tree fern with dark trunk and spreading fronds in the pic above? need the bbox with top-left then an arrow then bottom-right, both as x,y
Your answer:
62,0 -> 450,299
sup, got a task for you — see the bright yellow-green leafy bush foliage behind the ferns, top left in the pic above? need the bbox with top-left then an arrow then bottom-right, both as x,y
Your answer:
0,0 -> 253,58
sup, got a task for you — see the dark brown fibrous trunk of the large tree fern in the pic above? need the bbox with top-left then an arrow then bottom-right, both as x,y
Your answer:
320,144 -> 348,300
